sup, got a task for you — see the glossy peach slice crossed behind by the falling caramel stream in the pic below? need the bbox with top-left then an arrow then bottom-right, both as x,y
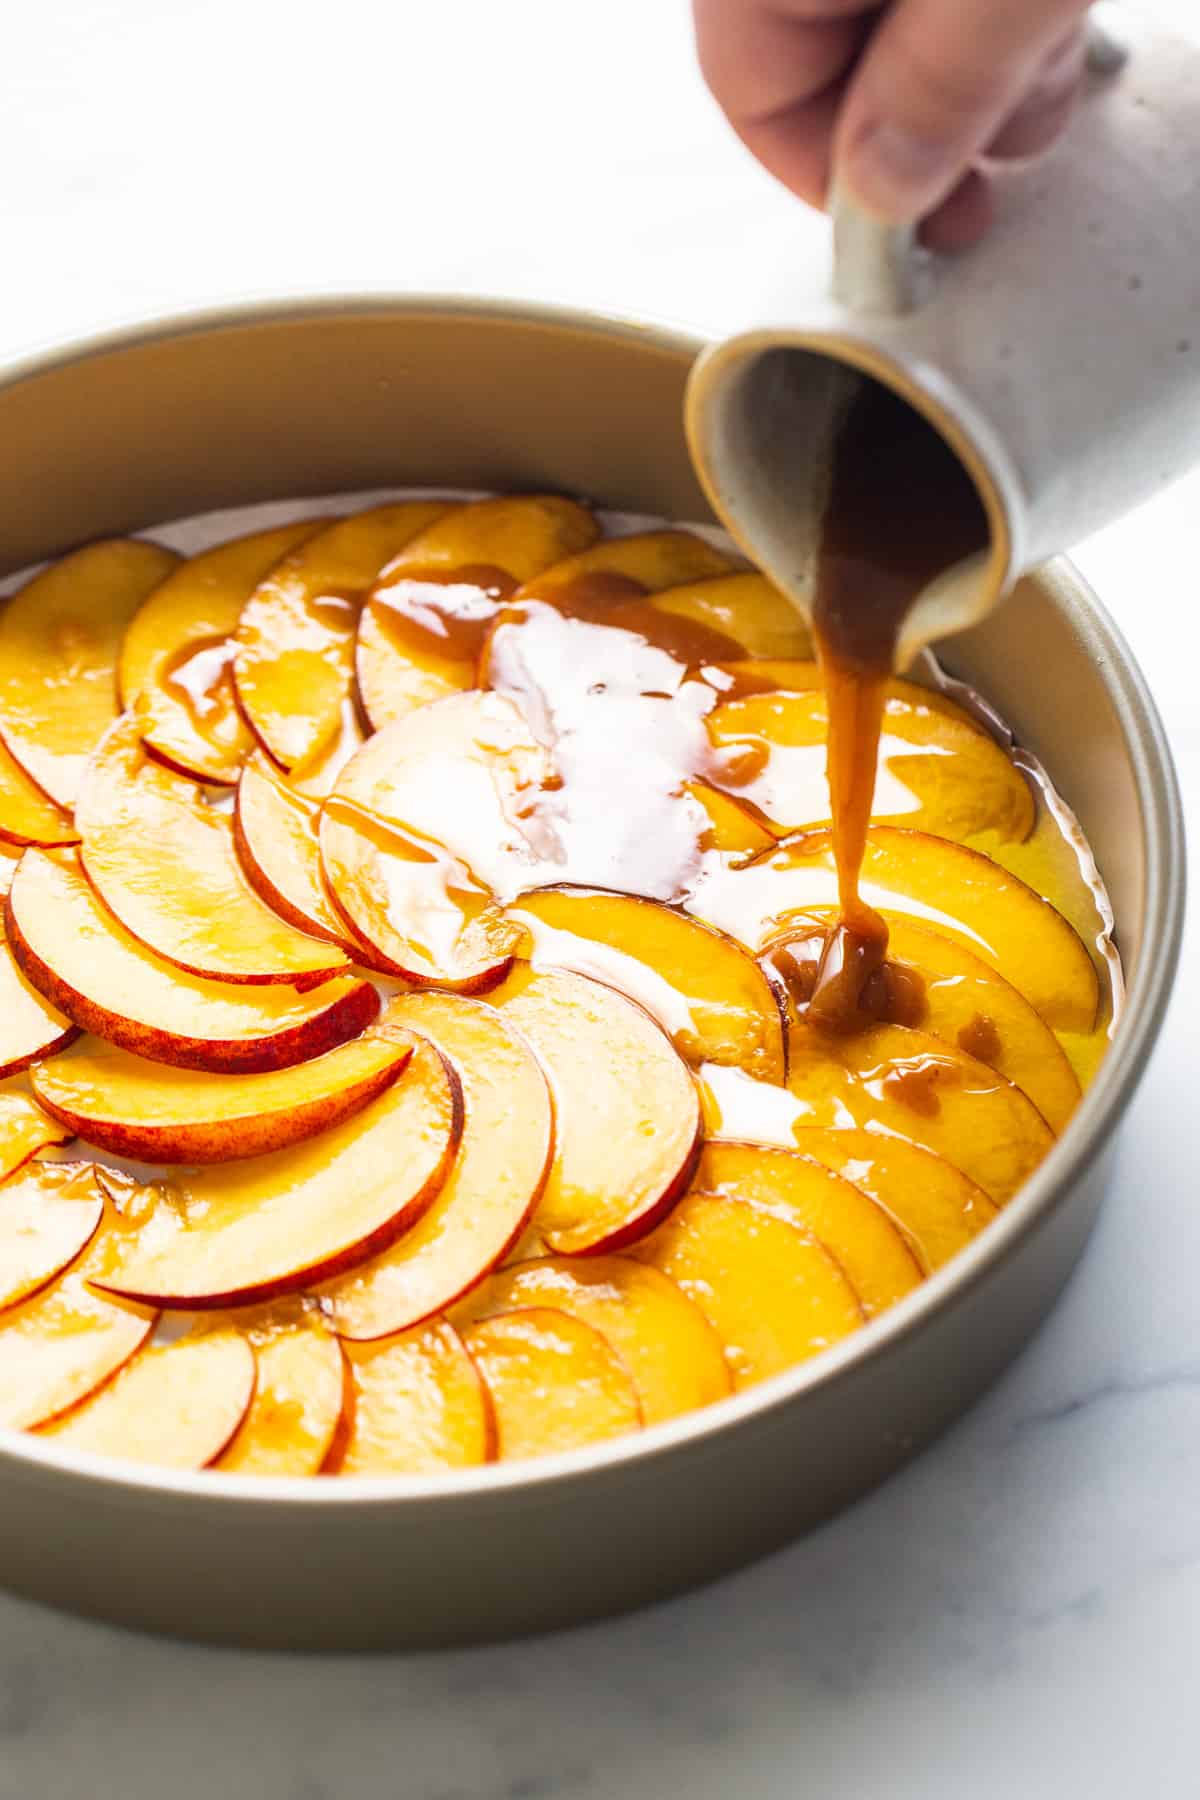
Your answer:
689,826 -> 1099,1031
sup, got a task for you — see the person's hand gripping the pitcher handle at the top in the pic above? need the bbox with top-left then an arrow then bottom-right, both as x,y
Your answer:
693,0 -> 1087,248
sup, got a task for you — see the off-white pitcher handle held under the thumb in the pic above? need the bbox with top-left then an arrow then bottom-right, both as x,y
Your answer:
829,7 -> 1128,319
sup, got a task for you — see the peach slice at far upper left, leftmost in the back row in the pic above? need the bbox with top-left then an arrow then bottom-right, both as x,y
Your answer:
0,538 -> 180,808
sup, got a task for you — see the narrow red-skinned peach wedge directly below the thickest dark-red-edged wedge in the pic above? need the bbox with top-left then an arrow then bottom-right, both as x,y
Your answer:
31,1030 -> 412,1163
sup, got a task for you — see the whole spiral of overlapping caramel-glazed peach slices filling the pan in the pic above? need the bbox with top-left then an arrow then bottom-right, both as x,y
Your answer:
0,495 -> 1114,1480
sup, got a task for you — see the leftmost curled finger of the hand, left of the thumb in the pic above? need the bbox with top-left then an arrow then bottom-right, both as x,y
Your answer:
693,0 -> 873,205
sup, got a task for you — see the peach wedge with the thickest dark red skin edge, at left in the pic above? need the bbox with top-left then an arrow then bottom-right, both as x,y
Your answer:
7,850 -> 380,1075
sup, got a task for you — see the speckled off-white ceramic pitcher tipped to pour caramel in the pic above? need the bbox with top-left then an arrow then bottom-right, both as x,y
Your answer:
687,14 -> 1200,666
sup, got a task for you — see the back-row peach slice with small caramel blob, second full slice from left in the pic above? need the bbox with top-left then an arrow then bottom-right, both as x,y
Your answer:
117,518 -> 320,783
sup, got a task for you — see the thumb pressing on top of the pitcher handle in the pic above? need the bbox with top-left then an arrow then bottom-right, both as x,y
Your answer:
835,0 -> 1087,220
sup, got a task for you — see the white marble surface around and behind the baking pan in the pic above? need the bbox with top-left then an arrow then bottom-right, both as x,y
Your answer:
0,0 -> 1200,1800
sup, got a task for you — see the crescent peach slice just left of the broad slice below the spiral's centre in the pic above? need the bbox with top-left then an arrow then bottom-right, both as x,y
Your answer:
326,994 -> 554,1337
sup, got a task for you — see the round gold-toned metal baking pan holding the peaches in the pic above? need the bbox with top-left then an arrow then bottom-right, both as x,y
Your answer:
0,297 -> 1184,1649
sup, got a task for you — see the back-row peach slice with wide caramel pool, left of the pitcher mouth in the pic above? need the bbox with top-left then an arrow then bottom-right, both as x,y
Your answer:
356,493 -> 597,731
